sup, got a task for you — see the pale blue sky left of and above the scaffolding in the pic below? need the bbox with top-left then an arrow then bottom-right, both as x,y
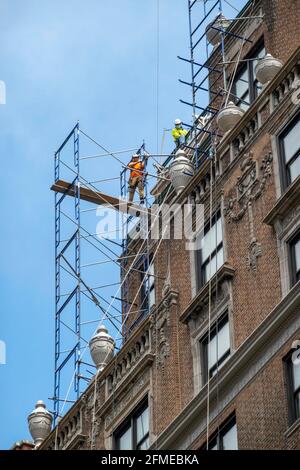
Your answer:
0,0 -> 245,449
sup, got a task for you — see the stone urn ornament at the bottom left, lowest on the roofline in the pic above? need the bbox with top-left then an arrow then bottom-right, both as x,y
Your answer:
28,400 -> 53,446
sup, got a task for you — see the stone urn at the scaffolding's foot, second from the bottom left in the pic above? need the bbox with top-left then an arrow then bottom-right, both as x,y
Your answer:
89,325 -> 115,371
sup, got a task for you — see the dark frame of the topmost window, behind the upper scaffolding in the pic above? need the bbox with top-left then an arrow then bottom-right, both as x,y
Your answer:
232,37 -> 266,111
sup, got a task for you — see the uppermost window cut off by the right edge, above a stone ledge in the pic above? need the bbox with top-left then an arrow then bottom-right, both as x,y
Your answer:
280,115 -> 300,187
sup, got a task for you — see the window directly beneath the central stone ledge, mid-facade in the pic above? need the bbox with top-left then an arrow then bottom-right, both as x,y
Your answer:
200,313 -> 231,382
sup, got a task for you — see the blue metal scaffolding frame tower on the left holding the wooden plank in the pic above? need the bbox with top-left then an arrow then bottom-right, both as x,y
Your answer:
51,122 -> 150,424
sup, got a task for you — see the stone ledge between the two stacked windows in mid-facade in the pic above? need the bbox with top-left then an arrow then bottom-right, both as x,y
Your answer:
179,263 -> 235,323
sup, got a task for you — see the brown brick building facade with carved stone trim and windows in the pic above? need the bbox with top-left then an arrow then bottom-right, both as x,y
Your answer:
40,0 -> 300,449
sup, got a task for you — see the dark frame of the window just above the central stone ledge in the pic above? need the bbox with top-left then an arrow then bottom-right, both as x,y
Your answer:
196,209 -> 224,291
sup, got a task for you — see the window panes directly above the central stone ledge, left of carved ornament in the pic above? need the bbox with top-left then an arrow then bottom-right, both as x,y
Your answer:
196,211 -> 224,288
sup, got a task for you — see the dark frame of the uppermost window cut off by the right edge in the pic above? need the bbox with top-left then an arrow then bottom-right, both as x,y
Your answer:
277,111 -> 300,191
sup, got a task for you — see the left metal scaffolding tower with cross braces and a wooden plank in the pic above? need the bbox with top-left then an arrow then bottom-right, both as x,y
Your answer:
51,123 -> 149,422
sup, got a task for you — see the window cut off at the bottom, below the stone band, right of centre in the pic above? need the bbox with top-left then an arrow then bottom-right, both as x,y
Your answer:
202,415 -> 238,450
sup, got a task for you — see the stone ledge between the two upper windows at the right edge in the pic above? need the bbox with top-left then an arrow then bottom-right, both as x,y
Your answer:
263,176 -> 300,225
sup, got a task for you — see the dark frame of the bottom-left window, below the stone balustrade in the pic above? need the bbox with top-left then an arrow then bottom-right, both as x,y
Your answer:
113,397 -> 150,450
